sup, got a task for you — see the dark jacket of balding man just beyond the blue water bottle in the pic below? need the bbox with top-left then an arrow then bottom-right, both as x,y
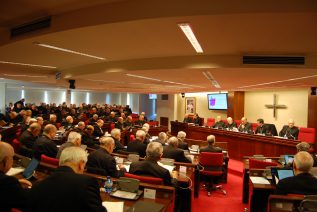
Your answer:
86,148 -> 125,178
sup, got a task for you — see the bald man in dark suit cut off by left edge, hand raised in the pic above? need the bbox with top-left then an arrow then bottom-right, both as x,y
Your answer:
0,142 -> 32,212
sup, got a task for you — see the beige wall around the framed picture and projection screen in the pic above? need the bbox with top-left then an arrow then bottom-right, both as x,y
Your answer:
175,92 -> 227,122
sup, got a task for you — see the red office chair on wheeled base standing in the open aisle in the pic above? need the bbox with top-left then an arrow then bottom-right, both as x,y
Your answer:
199,152 -> 227,196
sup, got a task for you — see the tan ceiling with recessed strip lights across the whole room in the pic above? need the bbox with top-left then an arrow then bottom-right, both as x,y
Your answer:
0,0 -> 317,93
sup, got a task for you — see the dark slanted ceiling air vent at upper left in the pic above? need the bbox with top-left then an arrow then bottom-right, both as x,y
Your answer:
11,17 -> 51,38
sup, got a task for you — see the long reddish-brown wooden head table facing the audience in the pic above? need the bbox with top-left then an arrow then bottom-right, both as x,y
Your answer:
171,121 -> 300,160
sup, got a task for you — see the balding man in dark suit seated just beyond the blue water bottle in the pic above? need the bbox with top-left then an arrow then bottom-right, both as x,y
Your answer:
87,137 -> 126,178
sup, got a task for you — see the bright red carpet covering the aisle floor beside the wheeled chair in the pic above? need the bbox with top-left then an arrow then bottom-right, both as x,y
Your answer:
192,159 -> 247,212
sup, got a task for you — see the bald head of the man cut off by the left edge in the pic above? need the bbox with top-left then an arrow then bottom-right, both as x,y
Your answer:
0,142 -> 14,173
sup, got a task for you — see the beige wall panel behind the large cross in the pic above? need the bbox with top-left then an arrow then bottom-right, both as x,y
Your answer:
244,89 -> 309,131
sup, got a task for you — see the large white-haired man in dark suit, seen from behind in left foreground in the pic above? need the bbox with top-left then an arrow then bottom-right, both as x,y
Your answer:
29,147 -> 107,212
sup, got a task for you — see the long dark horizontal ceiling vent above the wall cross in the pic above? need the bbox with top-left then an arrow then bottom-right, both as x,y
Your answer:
243,56 -> 305,65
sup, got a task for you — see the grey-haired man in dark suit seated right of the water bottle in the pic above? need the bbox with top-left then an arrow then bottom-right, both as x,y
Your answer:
129,142 -> 177,185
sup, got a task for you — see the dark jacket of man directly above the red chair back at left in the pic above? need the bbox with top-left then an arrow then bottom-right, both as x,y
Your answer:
33,135 -> 58,160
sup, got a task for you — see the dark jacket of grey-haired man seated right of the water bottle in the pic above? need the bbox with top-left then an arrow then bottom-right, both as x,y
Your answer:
129,160 -> 172,185
